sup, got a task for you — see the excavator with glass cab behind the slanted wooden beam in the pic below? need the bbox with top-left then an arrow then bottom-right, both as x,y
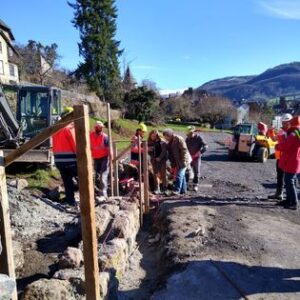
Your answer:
0,85 -> 61,165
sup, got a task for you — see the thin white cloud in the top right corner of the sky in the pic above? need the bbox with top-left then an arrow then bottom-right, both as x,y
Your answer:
259,0 -> 300,20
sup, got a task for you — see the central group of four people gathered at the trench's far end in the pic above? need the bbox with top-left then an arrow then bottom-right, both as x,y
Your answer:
131,123 -> 208,195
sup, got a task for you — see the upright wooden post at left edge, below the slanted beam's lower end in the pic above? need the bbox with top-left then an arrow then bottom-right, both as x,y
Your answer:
0,151 -> 18,300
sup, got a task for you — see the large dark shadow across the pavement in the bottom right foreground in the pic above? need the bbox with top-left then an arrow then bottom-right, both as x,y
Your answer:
152,260 -> 300,300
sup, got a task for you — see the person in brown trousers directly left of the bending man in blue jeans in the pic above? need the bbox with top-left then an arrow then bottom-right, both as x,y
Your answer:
148,129 -> 168,195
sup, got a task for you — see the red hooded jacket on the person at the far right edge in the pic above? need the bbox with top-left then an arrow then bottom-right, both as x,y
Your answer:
276,128 -> 300,174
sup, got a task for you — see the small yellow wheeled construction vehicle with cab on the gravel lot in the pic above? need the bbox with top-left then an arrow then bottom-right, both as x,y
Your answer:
228,123 -> 277,163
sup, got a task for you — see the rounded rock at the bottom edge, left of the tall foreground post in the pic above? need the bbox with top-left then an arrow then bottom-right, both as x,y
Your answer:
22,279 -> 76,300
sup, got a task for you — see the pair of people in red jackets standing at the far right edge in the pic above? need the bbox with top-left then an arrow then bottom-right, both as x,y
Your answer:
268,114 -> 300,210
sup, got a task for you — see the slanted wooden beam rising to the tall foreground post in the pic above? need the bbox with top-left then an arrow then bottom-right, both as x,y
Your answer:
5,113 -> 74,167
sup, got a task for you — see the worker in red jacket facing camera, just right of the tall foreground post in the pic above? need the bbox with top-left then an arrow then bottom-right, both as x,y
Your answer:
90,121 -> 110,198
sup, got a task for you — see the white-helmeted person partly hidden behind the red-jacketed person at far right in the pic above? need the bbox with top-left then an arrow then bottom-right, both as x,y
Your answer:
268,114 -> 293,205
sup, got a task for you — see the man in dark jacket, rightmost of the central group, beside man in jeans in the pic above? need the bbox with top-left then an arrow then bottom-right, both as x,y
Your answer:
185,126 -> 208,192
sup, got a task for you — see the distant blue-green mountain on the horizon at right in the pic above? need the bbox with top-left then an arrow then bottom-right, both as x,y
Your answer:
198,62 -> 300,100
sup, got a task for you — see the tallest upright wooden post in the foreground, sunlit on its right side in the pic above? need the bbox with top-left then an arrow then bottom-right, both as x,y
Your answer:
74,105 -> 100,300
